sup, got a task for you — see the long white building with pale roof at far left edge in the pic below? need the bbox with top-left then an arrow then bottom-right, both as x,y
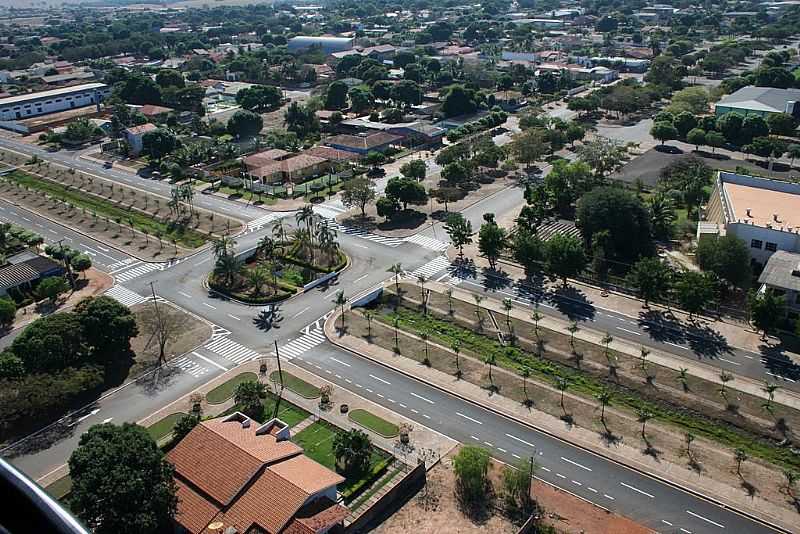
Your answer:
0,83 -> 111,121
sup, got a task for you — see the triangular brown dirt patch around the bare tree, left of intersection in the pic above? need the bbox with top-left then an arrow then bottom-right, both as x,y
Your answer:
129,302 -> 211,378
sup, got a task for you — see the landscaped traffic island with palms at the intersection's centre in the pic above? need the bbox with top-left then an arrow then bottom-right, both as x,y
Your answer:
208,205 -> 347,304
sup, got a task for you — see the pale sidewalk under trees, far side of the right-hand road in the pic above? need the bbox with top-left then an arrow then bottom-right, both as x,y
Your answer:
446,243 -> 800,364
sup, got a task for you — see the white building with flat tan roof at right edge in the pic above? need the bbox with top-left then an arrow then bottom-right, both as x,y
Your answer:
697,172 -> 800,266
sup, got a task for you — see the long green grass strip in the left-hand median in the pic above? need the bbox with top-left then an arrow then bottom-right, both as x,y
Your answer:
5,171 -> 208,248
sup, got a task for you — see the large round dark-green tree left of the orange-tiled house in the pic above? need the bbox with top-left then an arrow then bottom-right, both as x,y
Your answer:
69,423 -> 178,534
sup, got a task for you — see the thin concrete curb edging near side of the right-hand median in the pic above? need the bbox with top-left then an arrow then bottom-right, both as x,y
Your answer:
323,311 -> 792,534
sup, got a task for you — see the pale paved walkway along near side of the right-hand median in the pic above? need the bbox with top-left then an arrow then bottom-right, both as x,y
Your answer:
325,312 -> 797,531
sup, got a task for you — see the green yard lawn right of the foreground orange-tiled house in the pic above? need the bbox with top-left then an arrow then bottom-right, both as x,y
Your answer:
292,421 -> 391,496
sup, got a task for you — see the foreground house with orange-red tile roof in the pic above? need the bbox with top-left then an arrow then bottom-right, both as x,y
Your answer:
167,412 -> 348,534
